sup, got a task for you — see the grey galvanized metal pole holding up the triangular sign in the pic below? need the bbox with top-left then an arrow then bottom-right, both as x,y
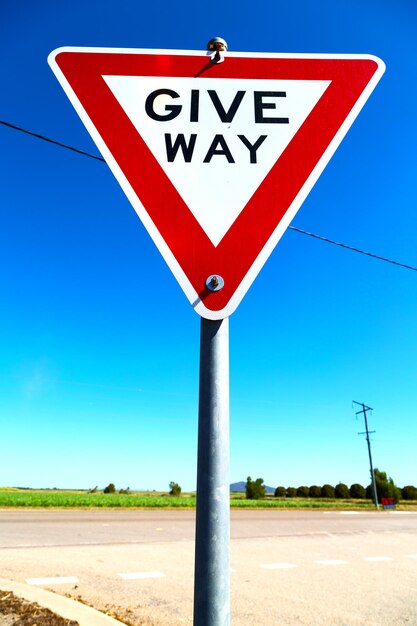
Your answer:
194,318 -> 230,626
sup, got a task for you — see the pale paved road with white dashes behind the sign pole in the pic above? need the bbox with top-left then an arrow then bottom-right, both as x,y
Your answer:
0,510 -> 417,626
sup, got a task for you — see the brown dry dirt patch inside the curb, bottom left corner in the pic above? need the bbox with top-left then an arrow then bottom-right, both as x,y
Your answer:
0,591 -> 79,626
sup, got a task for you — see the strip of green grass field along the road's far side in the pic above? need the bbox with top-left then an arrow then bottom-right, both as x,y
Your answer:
0,488 -> 404,509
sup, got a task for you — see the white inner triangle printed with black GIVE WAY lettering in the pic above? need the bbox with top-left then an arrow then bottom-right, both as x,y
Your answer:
103,76 -> 331,246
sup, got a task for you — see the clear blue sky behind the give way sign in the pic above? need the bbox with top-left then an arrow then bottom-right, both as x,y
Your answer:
0,0 -> 417,490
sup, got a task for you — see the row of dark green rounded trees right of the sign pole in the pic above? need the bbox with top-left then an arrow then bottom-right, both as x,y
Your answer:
246,469 -> 417,502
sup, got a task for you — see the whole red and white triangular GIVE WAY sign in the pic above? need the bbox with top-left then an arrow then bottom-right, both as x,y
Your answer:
48,48 -> 385,320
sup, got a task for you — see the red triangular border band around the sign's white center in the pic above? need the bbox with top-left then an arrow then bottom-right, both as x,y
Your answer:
49,49 -> 382,319
